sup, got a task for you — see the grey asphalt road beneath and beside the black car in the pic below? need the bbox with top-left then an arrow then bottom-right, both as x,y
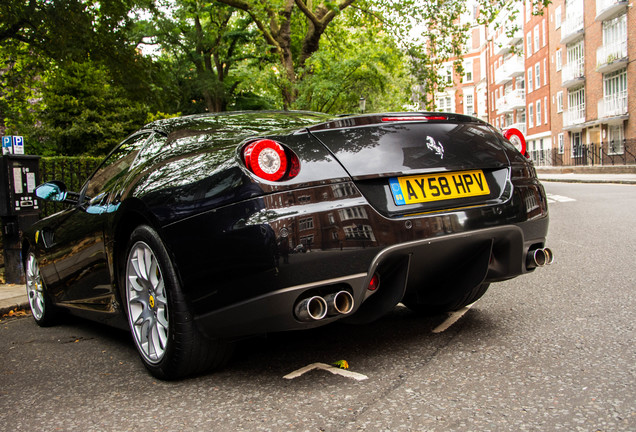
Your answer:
0,183 -> 636,431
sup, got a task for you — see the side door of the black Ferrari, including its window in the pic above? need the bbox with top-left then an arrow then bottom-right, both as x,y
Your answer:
48,132 -> 150,312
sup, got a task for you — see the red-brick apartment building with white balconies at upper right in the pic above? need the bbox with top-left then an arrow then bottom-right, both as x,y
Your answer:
434,0 -> 636,165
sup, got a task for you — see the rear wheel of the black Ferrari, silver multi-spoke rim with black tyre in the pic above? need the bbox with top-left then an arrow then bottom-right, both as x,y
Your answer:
121,225 -> 231,380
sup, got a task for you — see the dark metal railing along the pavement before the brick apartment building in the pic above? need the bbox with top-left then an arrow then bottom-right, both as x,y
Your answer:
529,139 -> 636,166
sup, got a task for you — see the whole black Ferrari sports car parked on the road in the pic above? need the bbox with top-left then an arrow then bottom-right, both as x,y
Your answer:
23,112 -> 553,379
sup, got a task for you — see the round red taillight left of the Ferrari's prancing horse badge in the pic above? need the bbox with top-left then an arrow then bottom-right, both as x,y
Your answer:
243,139 -> 299,181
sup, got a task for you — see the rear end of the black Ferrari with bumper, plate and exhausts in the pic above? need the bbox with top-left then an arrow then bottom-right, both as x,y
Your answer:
158,113 -> 548,336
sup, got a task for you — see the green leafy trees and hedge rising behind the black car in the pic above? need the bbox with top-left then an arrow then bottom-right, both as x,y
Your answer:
0,0 -> 549,155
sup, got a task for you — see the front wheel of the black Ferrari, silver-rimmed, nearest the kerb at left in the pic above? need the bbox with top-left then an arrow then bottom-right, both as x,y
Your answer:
24,251 -> 59,327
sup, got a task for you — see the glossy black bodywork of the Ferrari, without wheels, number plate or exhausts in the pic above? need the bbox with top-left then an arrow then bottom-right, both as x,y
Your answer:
24,112 -> 548,336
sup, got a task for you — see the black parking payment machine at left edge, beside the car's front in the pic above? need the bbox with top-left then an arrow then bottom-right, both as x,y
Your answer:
0,154 -> 40,283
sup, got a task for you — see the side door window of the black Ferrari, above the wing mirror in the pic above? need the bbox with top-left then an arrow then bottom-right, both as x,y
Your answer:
84,132 -> 150,201
